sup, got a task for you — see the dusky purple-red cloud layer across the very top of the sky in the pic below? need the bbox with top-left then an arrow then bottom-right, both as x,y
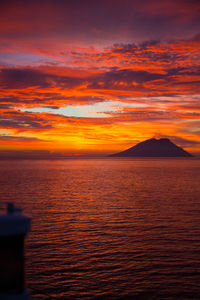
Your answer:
0,0 -> 200,42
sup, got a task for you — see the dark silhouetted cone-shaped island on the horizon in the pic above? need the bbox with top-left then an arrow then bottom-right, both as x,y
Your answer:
110,138 -> 193,157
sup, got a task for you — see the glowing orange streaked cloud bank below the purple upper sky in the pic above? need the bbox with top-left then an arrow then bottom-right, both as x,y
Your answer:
0,23 -> 200,154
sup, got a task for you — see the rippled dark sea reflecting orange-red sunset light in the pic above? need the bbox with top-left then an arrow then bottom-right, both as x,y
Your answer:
0,158 -> 200,299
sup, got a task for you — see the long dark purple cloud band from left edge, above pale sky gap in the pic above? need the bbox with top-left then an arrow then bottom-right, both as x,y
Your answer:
0,68 -> 165,91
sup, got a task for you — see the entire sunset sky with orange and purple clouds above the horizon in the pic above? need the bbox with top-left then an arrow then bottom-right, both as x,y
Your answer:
0,0 -> 200,156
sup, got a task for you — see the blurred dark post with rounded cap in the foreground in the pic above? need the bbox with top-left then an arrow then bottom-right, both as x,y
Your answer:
0,203 -> 30,300
